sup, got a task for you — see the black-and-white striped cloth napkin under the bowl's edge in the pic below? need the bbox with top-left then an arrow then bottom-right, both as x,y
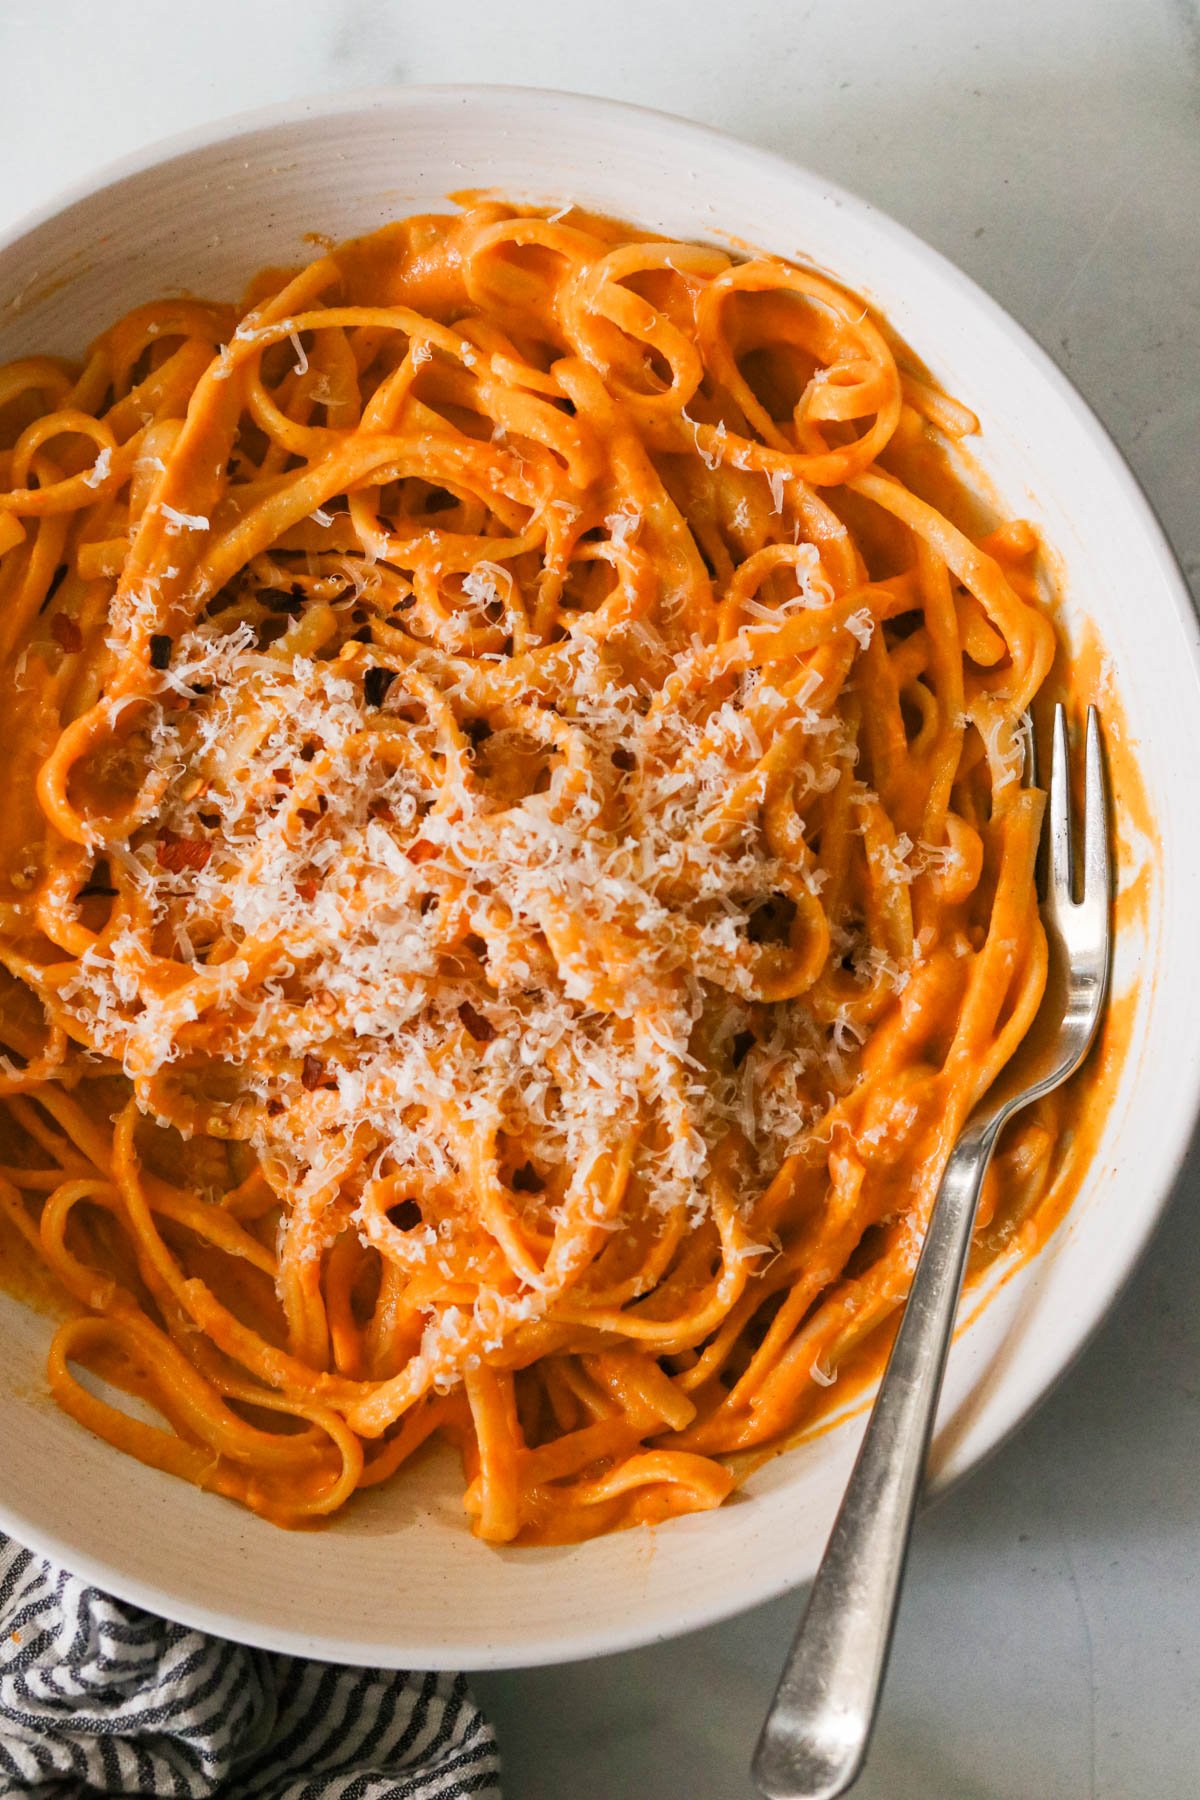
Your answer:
0,1535 -> 500,1800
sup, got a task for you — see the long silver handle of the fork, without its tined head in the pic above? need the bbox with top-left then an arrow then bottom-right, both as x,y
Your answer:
754,1116 -> 1002,1800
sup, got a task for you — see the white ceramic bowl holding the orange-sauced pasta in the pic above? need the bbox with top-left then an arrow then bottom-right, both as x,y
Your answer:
0,88 -> 1200,1667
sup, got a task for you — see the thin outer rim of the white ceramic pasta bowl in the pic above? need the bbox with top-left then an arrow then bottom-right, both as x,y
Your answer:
0,81 -> 1200,1669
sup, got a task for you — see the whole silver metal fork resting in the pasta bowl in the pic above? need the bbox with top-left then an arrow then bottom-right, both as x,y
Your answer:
754,706 -> 1110,1800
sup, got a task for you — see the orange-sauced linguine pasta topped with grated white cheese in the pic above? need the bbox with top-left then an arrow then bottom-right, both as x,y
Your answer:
0,202 -> 1093,1543
